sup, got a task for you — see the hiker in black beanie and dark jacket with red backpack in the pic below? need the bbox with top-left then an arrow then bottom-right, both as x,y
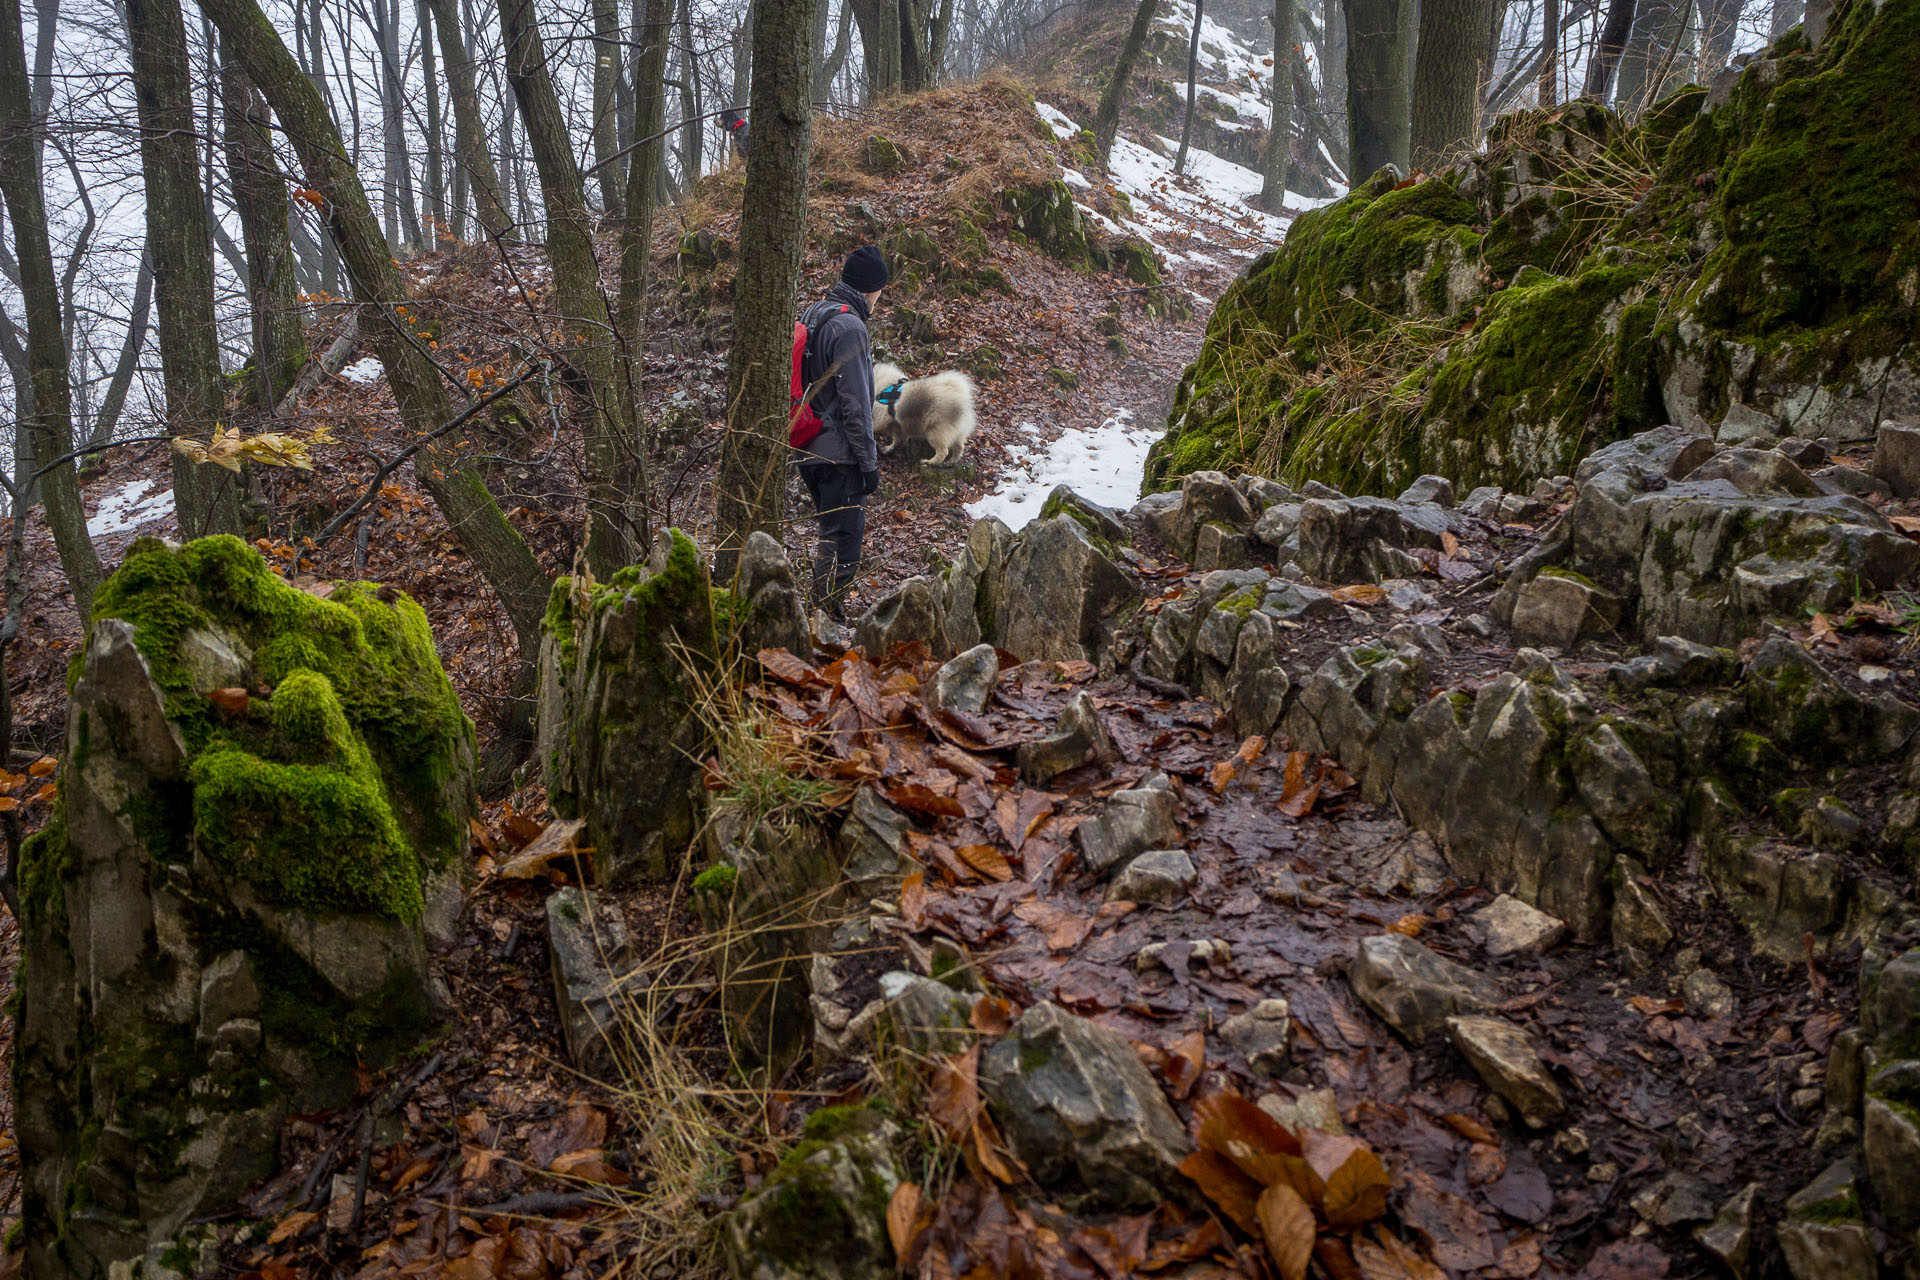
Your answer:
797,244 -> 887,618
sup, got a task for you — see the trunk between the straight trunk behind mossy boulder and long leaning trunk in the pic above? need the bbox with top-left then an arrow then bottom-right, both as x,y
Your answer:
221,58 -> 307,413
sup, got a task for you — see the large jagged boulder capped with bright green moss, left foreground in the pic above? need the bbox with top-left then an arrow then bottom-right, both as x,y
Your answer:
13,537 -> 474,1280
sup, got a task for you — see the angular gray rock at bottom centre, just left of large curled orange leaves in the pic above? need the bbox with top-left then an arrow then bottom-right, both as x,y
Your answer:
979,1004 -> 1192,1209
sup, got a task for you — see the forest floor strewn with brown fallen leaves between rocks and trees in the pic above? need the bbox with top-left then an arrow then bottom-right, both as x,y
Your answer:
0,27 -> 1881,1280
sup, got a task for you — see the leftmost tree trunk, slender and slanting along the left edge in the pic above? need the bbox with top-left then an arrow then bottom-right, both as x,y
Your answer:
0,0 -> 101,628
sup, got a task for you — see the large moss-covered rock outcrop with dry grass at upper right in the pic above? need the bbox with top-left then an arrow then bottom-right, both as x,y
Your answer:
1146,0 -> 1920,493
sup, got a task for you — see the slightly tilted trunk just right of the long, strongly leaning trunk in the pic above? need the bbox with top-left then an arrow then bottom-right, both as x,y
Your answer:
499,0 -> 645,580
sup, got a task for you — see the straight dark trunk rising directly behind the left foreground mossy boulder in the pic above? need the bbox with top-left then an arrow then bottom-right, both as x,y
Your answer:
125,0 -> 244,537
